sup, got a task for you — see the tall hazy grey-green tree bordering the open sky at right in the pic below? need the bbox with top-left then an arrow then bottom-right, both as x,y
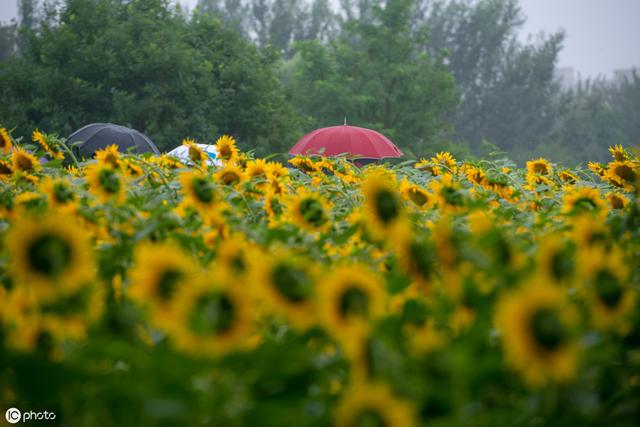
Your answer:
413,0 -> 564,154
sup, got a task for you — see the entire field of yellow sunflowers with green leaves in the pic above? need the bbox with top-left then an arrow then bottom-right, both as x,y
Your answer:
0,128 -> 640,427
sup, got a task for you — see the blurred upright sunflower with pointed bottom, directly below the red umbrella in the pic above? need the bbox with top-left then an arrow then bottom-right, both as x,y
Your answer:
318,265 -> 386,344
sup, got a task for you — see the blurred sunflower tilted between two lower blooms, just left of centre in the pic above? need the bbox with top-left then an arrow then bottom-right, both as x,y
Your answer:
251,249 -> 317,329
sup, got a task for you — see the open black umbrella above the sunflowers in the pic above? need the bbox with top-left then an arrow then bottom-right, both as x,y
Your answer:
67,123 -> 160,159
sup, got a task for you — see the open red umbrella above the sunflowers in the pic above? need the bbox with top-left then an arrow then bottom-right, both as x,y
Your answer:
289,125 -> 402,159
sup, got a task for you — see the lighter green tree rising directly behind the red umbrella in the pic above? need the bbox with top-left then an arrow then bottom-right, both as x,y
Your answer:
285,0 -> 456,153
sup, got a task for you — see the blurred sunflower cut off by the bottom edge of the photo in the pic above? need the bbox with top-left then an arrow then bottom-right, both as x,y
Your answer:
334,382 -> 417,427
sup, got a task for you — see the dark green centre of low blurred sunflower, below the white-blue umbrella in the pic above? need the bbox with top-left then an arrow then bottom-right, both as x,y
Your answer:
189,293 -> 236,335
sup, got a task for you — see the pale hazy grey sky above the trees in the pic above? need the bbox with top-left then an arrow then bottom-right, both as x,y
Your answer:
0,0 -> 640,77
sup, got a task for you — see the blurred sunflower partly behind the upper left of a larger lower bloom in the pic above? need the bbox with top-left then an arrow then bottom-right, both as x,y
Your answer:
126,243 -> 198,331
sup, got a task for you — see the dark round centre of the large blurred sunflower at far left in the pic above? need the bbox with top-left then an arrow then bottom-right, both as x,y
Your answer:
27,234 -> 73,277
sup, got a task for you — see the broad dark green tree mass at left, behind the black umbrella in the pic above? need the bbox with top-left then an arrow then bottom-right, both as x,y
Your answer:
0,0 -> 295,151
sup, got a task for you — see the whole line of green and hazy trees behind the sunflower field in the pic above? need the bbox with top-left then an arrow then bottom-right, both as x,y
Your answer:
0,0 -> 640,163
